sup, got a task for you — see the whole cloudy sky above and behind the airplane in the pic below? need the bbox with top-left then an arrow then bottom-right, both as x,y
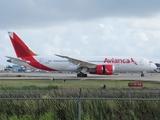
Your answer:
0,0 -> 160,66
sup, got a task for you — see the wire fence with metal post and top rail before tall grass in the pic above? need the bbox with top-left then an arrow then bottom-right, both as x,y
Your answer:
0,96 -> 160,120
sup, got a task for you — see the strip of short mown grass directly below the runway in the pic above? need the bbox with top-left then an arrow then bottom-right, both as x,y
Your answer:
0,80 -> 160,89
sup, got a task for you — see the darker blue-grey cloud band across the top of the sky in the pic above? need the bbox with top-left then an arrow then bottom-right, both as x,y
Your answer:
0,0 -> 160,29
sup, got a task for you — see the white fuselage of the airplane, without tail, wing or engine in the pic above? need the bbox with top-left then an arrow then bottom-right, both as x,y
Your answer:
28,56 -> 156,72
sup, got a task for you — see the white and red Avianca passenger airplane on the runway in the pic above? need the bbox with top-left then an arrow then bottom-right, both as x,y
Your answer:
6,32 -> 157,77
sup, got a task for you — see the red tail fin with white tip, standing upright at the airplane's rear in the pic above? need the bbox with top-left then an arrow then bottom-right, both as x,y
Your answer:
8,32 -> 37,58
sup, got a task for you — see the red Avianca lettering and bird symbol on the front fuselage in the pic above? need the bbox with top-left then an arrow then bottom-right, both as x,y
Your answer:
104,58 -> 138,65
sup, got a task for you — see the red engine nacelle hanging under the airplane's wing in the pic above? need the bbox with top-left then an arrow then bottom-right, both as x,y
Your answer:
91,64 -> 115,75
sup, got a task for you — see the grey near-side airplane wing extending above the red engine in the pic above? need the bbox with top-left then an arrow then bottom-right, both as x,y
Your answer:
55,54 -> 96,68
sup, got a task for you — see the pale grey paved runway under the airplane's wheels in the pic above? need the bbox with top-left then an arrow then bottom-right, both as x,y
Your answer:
0,73 -> 160,82
